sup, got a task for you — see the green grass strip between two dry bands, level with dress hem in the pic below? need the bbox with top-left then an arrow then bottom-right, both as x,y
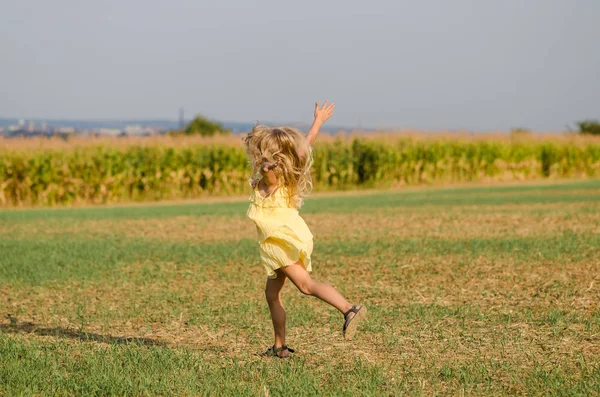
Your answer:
0,232 -> 600,285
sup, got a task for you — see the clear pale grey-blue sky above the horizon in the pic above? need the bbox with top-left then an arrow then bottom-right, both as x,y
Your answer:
0,0 -> 600,131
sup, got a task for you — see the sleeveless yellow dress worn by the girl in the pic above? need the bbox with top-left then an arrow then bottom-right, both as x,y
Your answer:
246,183 -> 313,278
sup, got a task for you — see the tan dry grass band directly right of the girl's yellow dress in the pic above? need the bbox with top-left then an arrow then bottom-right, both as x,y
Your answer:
304,205 -> 600,242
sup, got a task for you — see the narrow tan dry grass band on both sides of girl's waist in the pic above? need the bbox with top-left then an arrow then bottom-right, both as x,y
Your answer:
0,203 -> 600,243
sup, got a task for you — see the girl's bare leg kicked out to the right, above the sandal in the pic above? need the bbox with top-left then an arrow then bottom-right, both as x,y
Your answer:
278,263 -> 353,318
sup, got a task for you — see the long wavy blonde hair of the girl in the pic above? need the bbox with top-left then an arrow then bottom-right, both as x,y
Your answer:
244,125 -> 313,208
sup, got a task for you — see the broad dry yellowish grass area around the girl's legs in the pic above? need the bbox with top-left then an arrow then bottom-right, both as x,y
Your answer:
0,249 -> 600,362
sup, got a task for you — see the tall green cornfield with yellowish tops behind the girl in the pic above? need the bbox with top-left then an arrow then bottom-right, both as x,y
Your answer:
0,135 -> 600,207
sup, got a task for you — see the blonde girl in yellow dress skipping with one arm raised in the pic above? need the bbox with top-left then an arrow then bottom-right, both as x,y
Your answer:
244,101 -> 367,358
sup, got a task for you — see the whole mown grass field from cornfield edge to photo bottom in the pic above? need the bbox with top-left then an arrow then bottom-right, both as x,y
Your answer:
0,180 -> 600,396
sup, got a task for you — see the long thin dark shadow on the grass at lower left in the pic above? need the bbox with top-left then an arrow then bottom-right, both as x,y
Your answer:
0,322 -> 168,346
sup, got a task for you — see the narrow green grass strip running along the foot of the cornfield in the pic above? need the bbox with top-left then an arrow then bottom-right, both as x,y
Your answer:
0,179 -> 600,222
